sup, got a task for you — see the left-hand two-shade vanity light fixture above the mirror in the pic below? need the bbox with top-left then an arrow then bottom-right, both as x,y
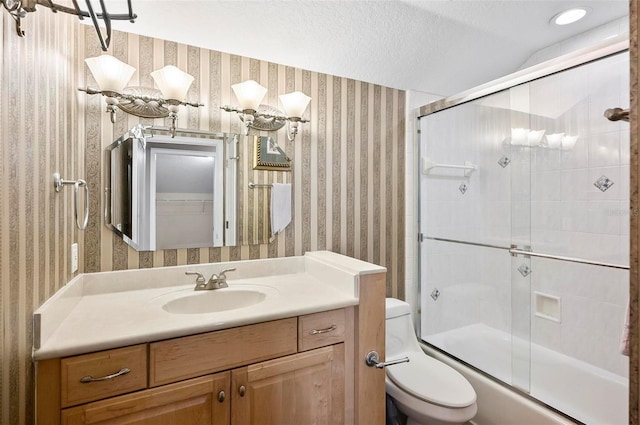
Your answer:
78,55 -> 204,137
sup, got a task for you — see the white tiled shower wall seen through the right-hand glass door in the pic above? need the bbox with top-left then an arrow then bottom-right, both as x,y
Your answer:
529,53 -> 630,376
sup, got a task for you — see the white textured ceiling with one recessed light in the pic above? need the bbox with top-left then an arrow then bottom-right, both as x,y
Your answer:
107,0 -> 628,95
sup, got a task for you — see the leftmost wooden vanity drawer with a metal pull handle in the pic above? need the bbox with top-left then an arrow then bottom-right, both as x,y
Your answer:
60,344 -> 147,407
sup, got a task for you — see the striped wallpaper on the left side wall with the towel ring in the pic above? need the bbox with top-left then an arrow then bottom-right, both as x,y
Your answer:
0,9 -> 84,425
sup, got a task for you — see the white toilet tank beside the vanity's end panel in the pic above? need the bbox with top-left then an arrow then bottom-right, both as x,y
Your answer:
385,298 -> 422,360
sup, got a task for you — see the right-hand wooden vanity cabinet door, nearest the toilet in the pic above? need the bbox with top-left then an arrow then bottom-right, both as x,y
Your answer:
231,344 -> 345,425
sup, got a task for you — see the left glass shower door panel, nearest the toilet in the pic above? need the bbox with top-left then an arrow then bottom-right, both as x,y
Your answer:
420,90 -> 530,391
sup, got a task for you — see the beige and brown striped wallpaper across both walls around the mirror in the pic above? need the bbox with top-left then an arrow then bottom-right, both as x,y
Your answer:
0,13 -> 405,425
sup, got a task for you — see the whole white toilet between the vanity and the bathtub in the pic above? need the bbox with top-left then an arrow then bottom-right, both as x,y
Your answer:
385,298 -> 478,425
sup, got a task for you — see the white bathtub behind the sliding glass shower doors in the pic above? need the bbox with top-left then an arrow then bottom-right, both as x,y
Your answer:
425,324 -> 628,425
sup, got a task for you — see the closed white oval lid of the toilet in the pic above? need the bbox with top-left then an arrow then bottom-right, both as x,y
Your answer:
386,353 -> 476,408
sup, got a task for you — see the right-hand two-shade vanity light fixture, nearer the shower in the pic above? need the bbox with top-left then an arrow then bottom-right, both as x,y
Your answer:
220,80 -> 311,141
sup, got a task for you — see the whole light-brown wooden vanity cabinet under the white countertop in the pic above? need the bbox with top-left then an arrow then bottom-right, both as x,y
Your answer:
35,273 -> 385,425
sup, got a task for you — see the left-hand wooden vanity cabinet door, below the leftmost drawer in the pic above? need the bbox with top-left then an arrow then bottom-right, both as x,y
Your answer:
62,372 -> 231,425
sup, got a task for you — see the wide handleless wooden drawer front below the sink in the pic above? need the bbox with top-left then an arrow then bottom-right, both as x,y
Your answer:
149,318 -> 297,387
